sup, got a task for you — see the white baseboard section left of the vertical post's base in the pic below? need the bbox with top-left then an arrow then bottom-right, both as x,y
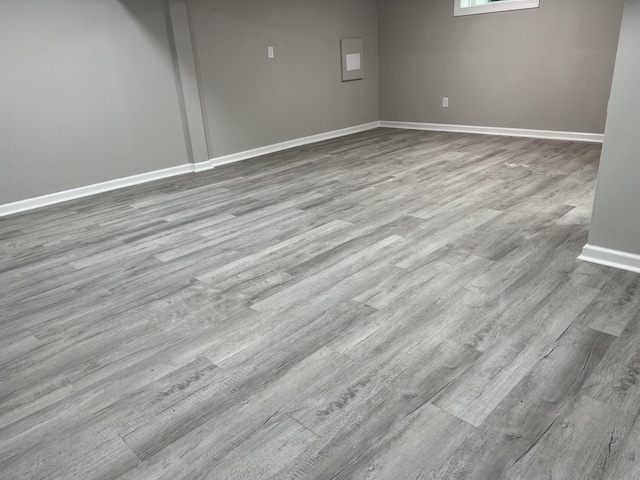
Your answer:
0,163 -> 194,217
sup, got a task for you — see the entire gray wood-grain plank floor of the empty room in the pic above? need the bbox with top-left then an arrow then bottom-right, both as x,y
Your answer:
0,129 -> 640,480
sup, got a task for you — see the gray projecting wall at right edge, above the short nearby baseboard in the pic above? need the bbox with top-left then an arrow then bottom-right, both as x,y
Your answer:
589,0 -> 640,255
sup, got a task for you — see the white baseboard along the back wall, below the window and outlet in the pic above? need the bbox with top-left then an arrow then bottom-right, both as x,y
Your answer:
378,120 -> 604,143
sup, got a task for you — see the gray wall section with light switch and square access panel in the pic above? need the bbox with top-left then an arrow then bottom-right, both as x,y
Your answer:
187,0 -> 378,158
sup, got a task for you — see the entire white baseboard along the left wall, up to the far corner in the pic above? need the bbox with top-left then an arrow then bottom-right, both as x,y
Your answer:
0,122 -> 378,217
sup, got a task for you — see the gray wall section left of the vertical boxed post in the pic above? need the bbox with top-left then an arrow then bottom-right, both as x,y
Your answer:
0,0 -> 187,204
